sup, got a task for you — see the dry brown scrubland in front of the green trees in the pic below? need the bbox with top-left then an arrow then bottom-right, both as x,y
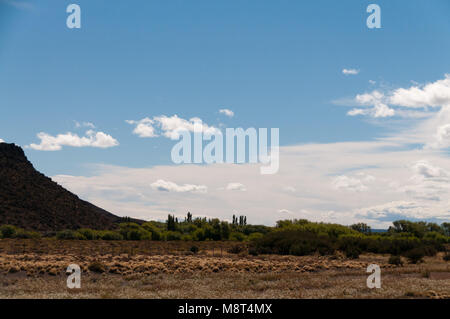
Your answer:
0,239 -> 450,298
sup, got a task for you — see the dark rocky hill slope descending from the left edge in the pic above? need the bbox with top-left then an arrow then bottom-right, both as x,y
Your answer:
0,143 -> 120,231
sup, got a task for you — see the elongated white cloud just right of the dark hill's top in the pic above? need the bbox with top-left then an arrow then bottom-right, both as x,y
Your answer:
27,130 -> 119,151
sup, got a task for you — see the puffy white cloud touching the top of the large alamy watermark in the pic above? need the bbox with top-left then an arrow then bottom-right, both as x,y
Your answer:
126,115 -> 221,140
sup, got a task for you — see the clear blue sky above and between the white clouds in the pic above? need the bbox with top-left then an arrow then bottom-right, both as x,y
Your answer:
0,0 -> 450,223
